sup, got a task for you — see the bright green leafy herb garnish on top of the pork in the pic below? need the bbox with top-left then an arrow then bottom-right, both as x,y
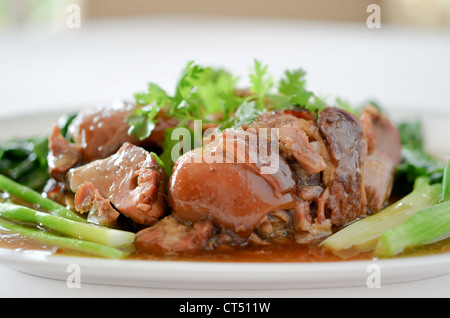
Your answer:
128,60 -> 356,171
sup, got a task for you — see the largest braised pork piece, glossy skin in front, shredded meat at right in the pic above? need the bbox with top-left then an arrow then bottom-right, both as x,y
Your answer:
164,108 -> 401,251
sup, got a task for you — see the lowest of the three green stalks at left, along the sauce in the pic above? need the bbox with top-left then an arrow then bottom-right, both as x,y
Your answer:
0,218 -> 128,259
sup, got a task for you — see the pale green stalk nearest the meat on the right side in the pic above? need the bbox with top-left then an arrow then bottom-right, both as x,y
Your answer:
322,177 -> 442,257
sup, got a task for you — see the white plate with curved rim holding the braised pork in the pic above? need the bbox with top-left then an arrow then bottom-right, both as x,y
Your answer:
0,113 -> 450,290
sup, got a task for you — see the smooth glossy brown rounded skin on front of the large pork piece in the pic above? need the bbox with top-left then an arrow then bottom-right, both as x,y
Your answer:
169,150 -> 294,237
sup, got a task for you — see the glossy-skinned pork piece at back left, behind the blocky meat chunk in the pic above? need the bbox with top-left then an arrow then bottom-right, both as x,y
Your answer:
48,102 -> 177,182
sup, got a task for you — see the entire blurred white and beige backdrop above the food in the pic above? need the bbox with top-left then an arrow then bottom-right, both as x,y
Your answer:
0,0 -> 450,123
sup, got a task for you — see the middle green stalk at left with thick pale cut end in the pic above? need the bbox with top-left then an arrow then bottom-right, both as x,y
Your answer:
0,203 -> 135,247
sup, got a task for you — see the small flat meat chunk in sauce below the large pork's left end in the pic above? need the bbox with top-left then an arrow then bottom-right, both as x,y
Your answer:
135,215 -> 214,253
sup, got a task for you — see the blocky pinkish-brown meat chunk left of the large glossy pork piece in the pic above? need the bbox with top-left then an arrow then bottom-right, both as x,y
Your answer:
68,142 -> 167,225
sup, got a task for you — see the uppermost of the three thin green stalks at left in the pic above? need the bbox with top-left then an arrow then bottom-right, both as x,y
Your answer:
0,174 -> 86,222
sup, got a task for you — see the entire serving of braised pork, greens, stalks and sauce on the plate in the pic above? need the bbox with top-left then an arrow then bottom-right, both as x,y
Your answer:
0,61 -> 450,261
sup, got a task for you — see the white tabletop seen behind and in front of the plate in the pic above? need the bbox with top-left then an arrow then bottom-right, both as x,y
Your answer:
0,16 -> 450,298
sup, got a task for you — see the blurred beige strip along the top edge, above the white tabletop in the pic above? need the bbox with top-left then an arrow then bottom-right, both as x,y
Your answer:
0,0 -> 450,29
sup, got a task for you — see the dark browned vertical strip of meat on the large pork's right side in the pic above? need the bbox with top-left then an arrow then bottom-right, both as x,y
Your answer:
318,108 -> 367,226
